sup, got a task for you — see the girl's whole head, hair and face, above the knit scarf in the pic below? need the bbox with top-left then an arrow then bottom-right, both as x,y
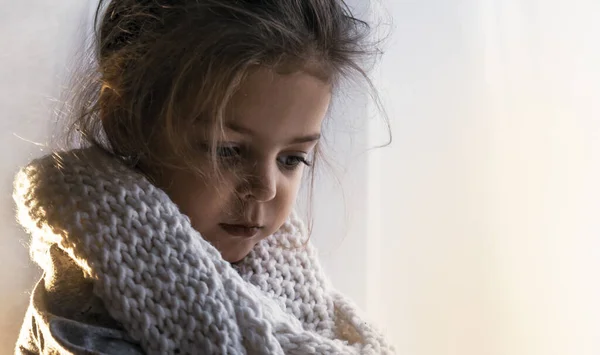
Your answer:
73,0 -> 376,262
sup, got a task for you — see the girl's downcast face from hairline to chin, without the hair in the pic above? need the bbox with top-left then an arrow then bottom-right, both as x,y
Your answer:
157,69 -> 331,262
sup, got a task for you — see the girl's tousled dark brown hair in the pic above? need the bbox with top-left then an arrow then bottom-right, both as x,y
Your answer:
63,0 -> 386,239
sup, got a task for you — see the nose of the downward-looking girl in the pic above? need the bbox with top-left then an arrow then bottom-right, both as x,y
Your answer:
244,162 -> 277,202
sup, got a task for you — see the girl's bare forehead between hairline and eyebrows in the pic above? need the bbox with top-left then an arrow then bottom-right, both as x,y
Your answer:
225,68 -> 331,141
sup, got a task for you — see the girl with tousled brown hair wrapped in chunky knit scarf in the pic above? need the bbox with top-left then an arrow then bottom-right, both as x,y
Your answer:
14,0 -> 393,354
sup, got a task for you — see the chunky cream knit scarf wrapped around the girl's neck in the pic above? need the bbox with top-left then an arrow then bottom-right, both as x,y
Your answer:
14,148 -> 393,355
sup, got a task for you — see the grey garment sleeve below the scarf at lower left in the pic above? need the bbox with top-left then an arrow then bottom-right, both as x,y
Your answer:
15,246 -> 144,355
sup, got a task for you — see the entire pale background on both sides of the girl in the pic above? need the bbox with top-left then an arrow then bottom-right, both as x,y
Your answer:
0,0 -> 600,355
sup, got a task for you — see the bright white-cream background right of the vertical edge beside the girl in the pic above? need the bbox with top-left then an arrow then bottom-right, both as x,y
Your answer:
367,0 -> 600,355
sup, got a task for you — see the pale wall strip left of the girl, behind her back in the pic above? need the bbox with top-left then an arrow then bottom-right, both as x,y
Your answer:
0,0 -> 93,354
